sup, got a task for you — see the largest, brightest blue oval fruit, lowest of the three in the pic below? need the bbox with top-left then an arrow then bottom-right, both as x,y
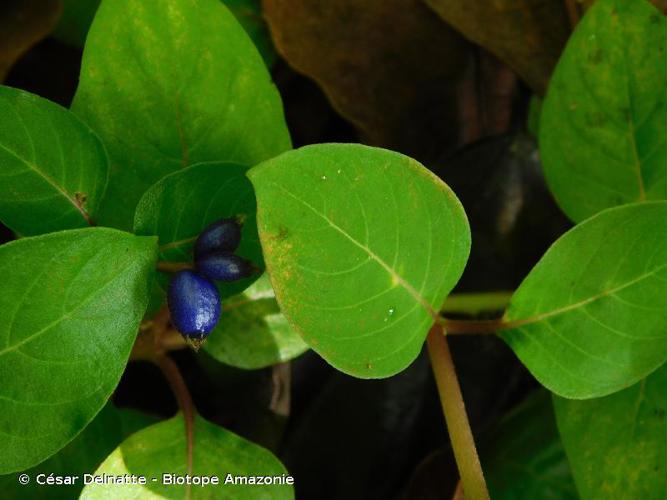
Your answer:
167,270 -> 220,348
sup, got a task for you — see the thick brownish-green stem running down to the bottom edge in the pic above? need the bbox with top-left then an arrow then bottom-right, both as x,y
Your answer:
427,324 -> 489,500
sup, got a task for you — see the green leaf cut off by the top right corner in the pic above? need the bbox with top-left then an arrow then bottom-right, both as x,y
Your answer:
540,0 -> 667,221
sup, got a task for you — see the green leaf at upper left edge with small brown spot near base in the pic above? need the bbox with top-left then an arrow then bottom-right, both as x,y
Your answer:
0,86 -> 107,236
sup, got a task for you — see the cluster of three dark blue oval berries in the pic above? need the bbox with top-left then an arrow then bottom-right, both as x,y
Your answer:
167,219 -> 255,349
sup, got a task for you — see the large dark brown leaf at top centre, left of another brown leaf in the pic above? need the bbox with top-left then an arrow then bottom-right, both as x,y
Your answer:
263,0 -> 473,161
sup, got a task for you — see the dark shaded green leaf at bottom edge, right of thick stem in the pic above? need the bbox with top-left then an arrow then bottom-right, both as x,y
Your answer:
480,390 -> 577,500
